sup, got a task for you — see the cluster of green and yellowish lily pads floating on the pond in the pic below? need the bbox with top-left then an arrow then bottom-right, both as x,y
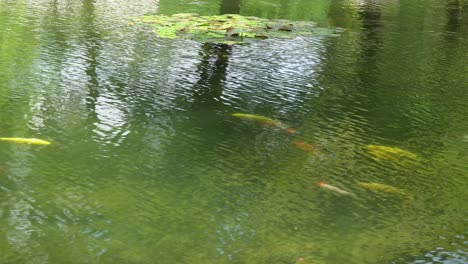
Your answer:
133,14 -> 341,44
